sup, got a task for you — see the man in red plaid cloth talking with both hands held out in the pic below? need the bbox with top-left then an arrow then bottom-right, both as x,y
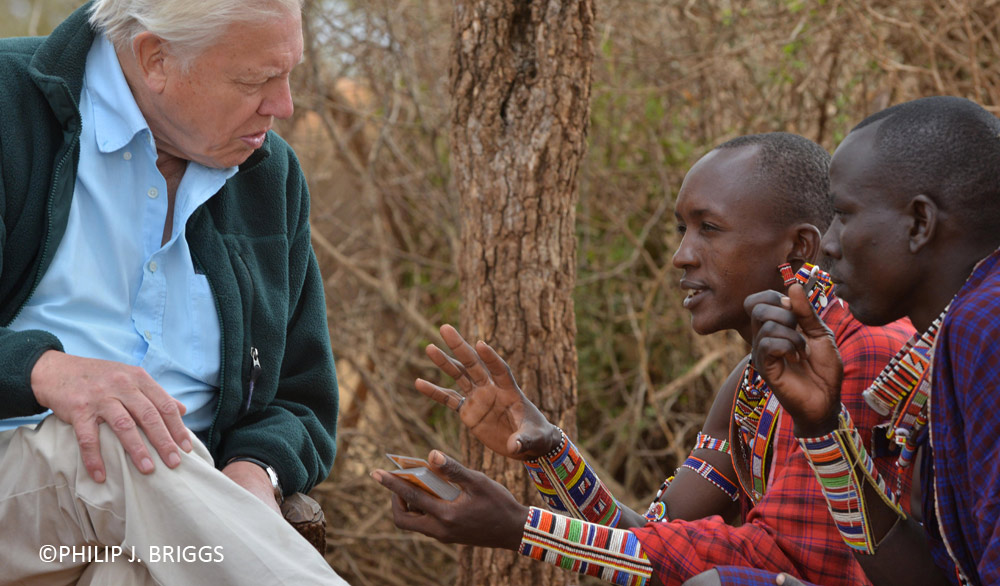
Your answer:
374,133 -> 912,586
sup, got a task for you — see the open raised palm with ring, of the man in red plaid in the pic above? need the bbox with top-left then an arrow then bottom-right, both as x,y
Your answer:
415,324 -> 562,460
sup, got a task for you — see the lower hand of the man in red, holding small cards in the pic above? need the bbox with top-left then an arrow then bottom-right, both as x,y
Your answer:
372,450 -> 528,551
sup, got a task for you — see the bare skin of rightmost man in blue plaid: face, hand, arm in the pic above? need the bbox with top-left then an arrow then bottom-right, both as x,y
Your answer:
745,123 -> 996,586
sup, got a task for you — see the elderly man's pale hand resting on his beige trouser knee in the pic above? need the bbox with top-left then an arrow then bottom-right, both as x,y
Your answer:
31,350 -> 191,482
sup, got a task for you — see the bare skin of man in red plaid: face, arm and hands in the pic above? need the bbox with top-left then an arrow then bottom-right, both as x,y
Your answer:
372,147 -> 820,580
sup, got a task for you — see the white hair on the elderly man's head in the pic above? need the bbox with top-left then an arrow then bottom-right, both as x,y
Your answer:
90,0 -> 303,58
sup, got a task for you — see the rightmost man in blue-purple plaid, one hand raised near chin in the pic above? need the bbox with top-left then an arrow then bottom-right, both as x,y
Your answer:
747,97 -> 1000,585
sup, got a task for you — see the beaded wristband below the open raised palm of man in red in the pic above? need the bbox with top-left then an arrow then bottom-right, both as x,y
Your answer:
524,430 -> 622,527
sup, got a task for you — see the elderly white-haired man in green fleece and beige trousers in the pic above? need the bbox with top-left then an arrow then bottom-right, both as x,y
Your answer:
0,0 -> 352,585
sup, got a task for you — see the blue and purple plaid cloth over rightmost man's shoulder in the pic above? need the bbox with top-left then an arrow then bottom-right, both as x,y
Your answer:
924,244 -> 1000,585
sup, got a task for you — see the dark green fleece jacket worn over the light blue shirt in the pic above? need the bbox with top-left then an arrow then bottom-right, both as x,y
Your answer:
0,6 -> 338,493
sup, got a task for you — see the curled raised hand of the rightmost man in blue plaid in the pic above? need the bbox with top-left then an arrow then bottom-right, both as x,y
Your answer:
743,283 -> 844,437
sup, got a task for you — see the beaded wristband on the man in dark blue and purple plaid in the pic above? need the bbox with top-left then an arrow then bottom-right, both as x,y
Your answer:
798,405 -> 906,555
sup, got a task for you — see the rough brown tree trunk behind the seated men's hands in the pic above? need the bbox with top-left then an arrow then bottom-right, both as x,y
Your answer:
450,0 -> 594,585
